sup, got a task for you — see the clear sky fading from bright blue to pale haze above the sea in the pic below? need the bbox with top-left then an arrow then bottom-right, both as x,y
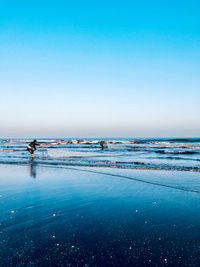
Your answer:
0,0 -> 200,137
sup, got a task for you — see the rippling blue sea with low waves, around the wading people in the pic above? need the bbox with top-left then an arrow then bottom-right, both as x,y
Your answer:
0,138 -> 200,171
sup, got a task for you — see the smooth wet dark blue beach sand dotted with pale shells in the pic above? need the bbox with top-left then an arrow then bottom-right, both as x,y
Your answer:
0,164 -> 200,266
